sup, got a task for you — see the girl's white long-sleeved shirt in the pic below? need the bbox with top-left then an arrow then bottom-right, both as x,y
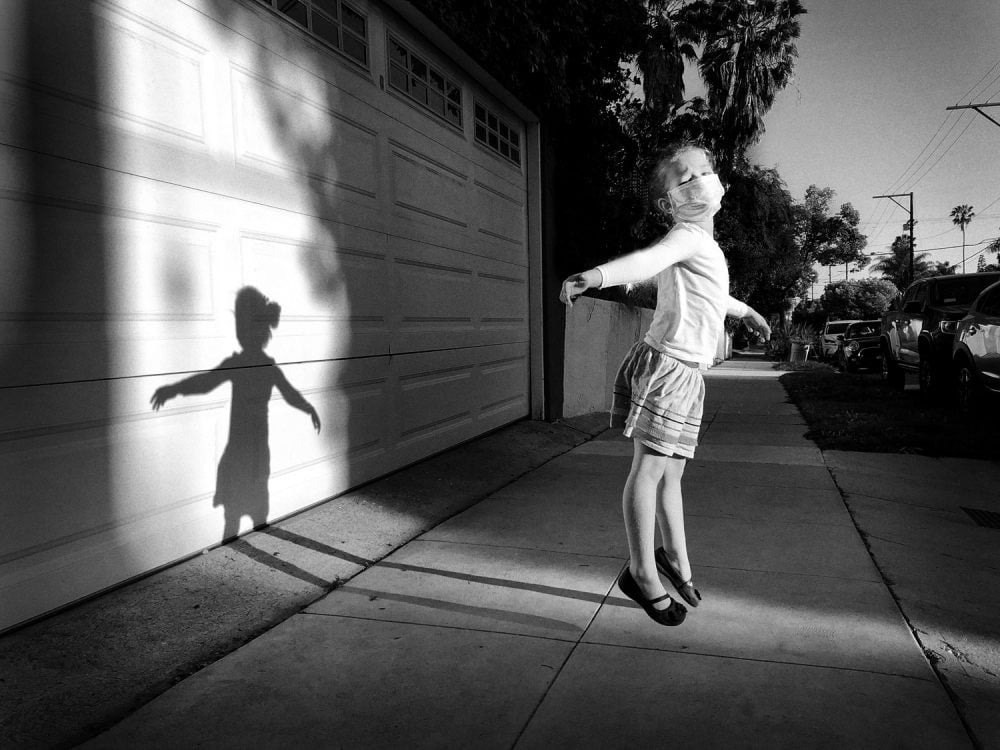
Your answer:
597,223 -> 748,365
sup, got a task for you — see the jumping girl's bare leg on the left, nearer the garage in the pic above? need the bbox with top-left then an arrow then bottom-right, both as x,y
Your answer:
622,440 -> 683,609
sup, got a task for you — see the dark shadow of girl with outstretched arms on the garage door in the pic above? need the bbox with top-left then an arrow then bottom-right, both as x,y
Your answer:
150,286 -> 320,541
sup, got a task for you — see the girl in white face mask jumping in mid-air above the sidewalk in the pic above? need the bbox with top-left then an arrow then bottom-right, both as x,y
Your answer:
559,144 -> 771,625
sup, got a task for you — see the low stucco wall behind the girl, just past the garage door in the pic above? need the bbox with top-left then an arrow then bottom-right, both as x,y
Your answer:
563,297 -> 732,417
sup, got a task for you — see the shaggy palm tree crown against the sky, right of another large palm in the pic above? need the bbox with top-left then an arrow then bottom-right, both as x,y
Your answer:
685,0 -> 806,163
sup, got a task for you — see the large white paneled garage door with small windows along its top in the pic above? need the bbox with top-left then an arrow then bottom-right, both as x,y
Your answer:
0,0 -> 529,629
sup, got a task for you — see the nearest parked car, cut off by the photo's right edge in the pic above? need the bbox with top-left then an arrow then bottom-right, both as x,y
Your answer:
952,283 -> 1000,411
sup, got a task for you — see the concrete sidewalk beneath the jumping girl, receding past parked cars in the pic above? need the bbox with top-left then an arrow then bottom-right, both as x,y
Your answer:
85,362 -> 986,749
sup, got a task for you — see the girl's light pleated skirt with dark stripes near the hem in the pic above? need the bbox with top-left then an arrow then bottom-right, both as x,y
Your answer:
611,341 -> 705,458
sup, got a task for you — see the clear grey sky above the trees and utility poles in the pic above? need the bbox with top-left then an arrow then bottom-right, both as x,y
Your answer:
751,0 -> 1000,296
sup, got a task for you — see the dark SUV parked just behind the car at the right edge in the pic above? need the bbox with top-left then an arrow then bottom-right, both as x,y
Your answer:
879,271 -> 1000,396
